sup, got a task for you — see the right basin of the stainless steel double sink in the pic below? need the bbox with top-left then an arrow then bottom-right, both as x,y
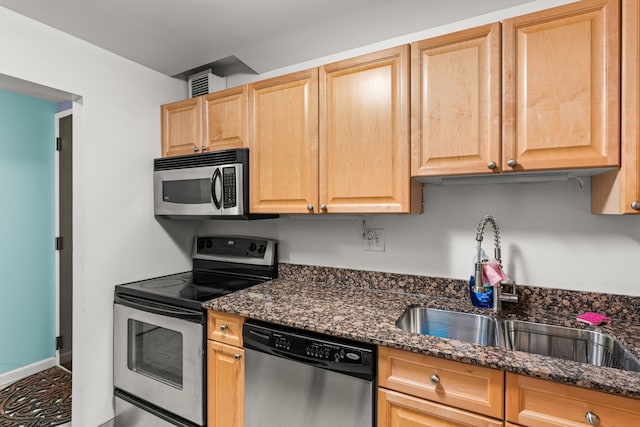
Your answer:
503,320 -> 640,371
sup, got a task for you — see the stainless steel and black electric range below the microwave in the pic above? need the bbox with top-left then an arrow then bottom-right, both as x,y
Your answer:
113,236 -> 278,427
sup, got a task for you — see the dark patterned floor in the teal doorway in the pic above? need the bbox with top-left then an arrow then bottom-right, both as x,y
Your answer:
0,366 -> 71,427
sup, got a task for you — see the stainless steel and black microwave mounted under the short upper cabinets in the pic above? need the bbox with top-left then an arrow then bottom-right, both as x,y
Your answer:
153,148 -> 277,219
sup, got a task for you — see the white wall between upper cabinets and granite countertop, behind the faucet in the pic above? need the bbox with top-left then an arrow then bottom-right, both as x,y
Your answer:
199,178 -> 640,296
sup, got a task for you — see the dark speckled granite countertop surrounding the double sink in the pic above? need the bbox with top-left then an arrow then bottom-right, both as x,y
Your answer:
203,265 -> 640,399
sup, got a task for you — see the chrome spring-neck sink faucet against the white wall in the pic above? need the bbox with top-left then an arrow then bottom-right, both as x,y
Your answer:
473,215 -> 518,313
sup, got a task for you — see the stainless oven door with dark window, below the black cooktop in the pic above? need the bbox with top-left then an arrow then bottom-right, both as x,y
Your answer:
113,297 -> 204,425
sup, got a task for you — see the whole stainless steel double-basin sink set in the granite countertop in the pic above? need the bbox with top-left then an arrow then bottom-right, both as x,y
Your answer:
396,306 -> 640,372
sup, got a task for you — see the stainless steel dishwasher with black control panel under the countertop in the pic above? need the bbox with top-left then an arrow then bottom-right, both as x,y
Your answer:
242,321 -> 376,427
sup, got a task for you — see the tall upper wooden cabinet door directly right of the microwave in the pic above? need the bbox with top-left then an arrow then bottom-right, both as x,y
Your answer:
249,69 -> 319,213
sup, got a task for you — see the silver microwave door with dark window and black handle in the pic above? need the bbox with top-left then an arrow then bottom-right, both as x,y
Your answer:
153,166 -> 222,216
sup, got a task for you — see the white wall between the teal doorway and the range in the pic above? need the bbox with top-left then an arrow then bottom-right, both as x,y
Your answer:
0,8 -> 198,426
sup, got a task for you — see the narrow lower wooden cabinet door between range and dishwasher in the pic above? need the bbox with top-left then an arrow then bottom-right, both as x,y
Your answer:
207,341 -> 244,427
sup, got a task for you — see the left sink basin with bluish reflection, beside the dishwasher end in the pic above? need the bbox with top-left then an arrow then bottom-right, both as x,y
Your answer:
396,307 -> 499,347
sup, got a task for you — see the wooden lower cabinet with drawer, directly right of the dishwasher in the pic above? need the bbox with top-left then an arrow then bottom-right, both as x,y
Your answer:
378,346 -> 504,427
